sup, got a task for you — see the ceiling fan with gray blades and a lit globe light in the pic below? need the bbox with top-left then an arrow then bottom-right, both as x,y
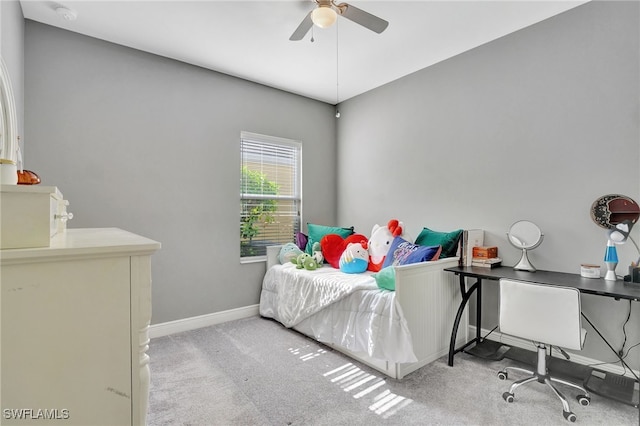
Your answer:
289,0 -> 389,41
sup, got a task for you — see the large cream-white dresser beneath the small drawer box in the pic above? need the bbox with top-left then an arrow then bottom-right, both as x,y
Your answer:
0,228 -> 160,425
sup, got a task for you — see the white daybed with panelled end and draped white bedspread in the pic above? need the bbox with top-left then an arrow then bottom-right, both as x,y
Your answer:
260,246 -> 468,379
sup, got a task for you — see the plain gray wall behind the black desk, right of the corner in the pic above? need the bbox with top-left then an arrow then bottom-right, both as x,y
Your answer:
338,2 -> 640,368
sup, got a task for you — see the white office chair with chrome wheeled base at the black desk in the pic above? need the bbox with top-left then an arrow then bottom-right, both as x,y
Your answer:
498,278 -> 591,422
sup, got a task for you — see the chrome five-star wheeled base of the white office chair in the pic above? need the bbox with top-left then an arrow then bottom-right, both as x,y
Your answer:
498,345 -> 591,422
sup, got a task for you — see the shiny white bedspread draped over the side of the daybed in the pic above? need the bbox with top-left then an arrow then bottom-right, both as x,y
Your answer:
260,264 -> 417,362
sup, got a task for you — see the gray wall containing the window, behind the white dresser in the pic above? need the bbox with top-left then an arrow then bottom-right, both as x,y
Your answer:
25,21 -> 336,323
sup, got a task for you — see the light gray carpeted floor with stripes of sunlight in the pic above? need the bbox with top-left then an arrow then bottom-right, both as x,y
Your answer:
148,317 -> 639,426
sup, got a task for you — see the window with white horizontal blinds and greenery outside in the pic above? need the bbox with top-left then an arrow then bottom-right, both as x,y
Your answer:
240,132 -> 302,260
